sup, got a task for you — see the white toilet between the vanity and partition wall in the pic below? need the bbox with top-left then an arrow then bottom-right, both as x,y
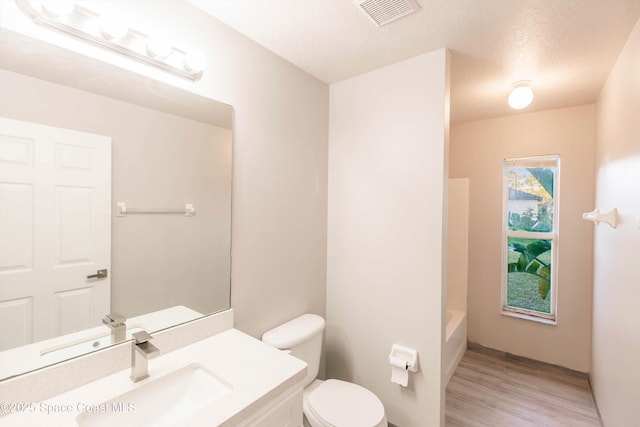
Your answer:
262,314 -> 387,427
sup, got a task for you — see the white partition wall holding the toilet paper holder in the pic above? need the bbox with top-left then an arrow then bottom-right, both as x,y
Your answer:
326,50 -> 449,427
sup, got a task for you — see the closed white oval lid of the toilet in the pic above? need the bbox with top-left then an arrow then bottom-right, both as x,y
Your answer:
307,380 -> 384,427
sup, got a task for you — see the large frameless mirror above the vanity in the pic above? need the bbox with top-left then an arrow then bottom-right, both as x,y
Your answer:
0,29 -> 233,379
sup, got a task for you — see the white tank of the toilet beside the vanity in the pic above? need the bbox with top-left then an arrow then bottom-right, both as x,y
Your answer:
262,314 -> 324,387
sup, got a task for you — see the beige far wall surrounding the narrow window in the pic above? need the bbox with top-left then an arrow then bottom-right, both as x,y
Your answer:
450,105 -> 595,372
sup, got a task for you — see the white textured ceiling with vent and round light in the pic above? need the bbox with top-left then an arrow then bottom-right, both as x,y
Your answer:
191,0 -> 640,122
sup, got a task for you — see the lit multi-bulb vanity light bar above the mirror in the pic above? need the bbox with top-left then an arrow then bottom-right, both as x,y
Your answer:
16,0 -> 207,81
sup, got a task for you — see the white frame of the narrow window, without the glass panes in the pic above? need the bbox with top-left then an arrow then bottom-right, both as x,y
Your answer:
500,154 -> 560,325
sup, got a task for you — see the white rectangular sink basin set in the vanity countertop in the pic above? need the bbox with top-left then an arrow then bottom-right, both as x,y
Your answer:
76,363 -> 233,427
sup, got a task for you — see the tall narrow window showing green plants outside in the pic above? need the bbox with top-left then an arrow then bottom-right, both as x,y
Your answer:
502,155 -> 560,323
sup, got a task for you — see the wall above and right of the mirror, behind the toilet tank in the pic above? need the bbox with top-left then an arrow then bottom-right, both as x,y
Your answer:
0,1 -> 329,336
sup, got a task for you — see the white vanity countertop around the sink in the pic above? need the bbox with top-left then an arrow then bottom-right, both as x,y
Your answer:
0,329 -> 306,427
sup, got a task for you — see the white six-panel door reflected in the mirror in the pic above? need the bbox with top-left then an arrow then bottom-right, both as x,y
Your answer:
0,118 -> 111,350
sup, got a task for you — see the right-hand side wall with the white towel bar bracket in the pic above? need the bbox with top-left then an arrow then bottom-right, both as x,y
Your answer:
591,16 -> 640,426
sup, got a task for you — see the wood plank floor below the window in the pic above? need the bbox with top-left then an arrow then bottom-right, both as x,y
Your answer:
445,350 -> 600,427
